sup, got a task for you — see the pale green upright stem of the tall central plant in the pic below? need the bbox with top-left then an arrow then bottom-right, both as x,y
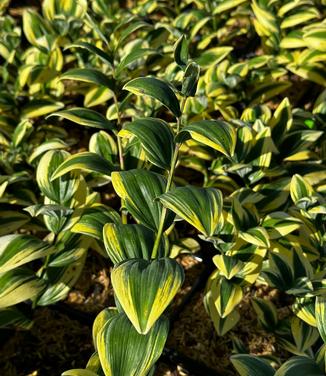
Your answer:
152,97 -> 187,259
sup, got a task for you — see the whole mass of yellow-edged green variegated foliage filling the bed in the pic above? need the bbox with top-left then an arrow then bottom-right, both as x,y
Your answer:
0,0 -> 326,376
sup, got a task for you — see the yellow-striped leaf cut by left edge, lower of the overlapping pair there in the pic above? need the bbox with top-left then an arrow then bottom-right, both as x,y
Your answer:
0,267 -> 45,309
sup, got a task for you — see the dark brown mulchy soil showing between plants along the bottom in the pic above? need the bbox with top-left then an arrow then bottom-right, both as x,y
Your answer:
0,252 -> 288,376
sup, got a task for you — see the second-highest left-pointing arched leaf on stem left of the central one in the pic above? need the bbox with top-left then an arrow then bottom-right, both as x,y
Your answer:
60,68 -> 114,91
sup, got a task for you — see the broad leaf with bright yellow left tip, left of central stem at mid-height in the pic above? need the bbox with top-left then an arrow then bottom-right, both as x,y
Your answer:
111,169 -> 174,231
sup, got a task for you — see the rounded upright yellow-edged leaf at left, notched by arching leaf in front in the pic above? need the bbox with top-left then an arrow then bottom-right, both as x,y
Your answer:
36,150 -> 79,204
